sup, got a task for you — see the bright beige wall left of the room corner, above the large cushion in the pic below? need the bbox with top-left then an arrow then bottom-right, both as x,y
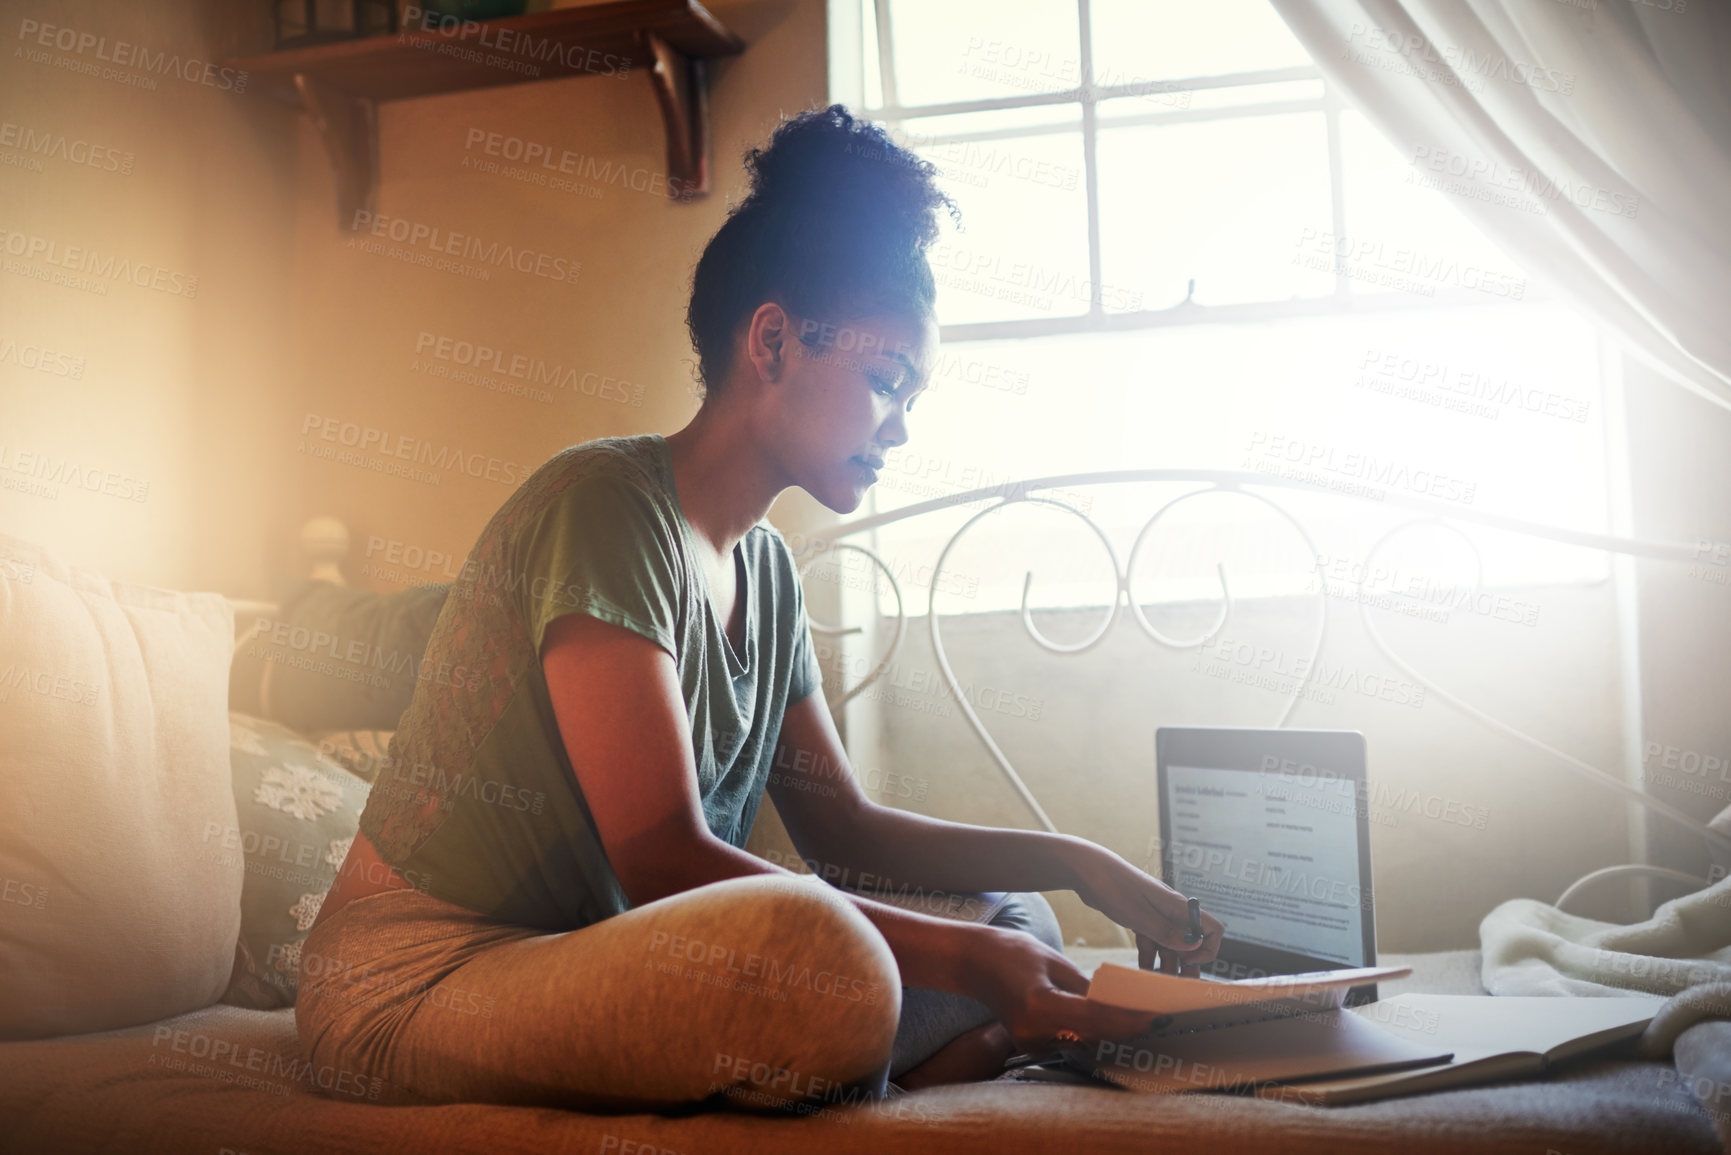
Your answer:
0,0 -> 296,592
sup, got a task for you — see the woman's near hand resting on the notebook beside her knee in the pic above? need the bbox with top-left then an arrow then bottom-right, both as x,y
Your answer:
966,926 -> 1156,1051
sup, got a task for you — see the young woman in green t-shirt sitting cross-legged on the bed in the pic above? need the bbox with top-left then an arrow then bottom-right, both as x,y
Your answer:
296,106 -> 1220,1110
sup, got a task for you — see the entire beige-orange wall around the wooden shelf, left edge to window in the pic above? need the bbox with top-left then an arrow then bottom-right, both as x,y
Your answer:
0,0 -> 826,597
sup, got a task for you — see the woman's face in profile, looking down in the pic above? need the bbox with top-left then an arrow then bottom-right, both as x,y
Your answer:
774,306 -> 938,513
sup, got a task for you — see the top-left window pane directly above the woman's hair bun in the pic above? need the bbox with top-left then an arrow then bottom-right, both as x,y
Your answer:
879,0 -> 1082,106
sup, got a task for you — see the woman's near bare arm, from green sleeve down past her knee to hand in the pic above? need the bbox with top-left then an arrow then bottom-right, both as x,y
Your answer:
542,613 -> 1151,1041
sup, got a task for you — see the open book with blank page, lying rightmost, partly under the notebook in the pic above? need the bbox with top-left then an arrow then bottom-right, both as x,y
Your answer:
1283,994 -> 1663,1107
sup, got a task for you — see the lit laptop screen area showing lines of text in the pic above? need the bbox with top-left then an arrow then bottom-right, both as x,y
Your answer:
1165,765 -> 1366,966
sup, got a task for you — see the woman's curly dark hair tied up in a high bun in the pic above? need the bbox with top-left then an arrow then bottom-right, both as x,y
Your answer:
685,104 -> 961,397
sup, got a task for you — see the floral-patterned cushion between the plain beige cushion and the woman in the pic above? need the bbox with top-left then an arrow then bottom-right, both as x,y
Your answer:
221,713 -> 367,1010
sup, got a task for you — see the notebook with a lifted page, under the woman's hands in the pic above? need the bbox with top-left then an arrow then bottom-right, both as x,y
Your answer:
1063,963 -> 1451,1094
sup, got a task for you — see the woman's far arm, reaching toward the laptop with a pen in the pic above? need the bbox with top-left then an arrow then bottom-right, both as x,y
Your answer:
770,693 -> 1224,970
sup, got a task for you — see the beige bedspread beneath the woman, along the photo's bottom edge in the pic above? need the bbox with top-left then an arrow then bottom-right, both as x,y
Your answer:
0,951 -> 1719,1155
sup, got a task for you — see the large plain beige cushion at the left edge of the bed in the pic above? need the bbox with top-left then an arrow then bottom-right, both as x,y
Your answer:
0,535 -> 242,1039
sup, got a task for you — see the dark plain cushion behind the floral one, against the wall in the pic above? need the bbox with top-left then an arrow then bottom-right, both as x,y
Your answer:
230,582 -> 460,732
